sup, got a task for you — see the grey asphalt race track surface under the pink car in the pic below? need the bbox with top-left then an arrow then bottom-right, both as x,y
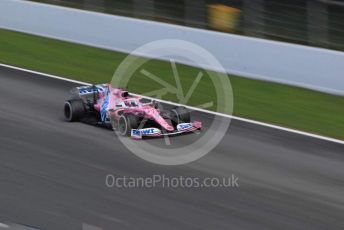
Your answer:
0,67 -> 344,230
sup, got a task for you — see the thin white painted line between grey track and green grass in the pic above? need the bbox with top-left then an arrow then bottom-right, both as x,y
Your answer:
0,63 -> 344,145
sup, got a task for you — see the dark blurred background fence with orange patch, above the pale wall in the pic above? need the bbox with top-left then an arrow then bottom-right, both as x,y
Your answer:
28,0 -> 344,50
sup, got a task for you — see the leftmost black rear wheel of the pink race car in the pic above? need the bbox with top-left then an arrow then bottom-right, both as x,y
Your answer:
64,99 -> 85,122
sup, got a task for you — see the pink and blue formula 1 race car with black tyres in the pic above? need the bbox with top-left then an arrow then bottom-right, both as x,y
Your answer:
64,84 -> 202,139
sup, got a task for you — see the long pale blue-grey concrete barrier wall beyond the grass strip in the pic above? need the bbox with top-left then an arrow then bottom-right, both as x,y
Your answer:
0,0 -> 344,95
